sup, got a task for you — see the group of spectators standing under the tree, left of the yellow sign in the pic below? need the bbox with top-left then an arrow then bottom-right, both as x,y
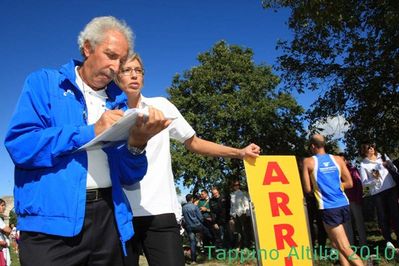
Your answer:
182,180 -> 254,263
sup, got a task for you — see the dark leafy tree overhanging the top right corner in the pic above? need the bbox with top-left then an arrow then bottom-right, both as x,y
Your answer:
262,0 -> 399,156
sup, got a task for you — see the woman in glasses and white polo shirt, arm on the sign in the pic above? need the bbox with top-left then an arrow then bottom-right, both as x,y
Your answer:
116,54 -> 260,266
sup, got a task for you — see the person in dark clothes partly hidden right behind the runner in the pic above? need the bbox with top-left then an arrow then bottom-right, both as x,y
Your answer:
339,153 -> 367,247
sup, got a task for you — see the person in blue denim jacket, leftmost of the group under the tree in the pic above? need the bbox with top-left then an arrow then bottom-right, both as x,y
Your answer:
182,194 -> 211,262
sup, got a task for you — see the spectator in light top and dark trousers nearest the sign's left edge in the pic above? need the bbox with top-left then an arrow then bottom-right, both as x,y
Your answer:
229,180 -> 252,248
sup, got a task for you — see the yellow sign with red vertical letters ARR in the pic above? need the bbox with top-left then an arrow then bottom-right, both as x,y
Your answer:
244,156 -> 313,266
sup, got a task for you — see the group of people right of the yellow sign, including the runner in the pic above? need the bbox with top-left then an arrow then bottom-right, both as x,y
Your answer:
302,138 -> 399,265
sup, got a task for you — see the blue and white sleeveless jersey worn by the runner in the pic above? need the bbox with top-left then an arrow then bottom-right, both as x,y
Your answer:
311,154 -> 349,210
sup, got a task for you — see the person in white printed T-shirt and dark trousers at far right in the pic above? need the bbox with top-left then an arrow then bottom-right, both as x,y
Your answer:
360,143 -> 399,248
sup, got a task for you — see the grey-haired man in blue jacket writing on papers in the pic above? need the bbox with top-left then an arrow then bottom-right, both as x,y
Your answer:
5,17 -> 171,266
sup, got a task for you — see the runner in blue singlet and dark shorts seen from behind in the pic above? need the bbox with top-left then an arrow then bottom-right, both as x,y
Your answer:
302,134 -> 363,265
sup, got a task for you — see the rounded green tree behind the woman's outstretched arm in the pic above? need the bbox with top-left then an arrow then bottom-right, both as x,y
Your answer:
168,41 -> 303,188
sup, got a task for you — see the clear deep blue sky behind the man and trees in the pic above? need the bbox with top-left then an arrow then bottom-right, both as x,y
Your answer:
0,0 -> 318,197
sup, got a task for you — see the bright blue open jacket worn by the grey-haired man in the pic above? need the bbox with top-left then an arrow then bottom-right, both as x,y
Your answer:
5,60 -> 147,254
